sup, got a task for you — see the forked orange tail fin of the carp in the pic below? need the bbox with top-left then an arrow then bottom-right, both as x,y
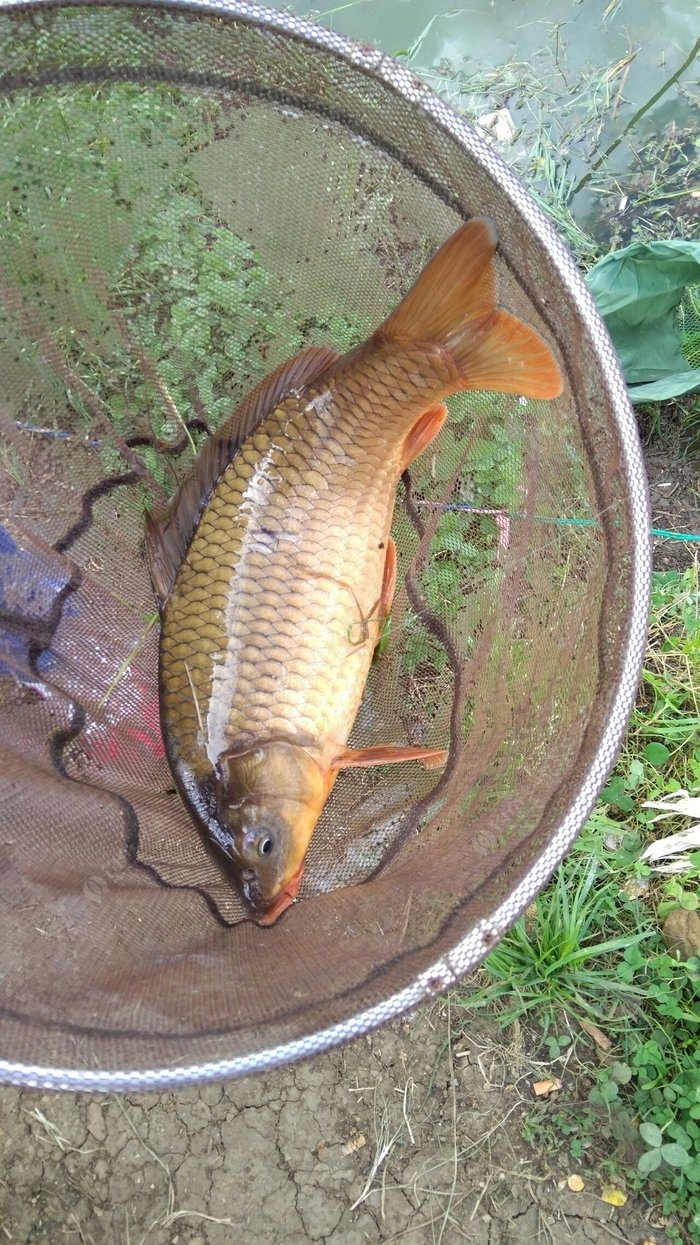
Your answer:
377,219 -> 562,398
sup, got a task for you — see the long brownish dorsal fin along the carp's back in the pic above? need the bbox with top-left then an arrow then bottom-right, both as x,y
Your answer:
146,346 -> 340,606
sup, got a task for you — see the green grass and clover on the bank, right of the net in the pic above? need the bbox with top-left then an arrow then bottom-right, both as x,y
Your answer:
452,564 -> 700,1245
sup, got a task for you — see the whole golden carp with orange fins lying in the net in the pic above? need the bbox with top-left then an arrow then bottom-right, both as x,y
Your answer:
146,218 -> 562,925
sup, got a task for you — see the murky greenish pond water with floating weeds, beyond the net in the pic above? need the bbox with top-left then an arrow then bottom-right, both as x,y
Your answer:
291,0 -> 699,242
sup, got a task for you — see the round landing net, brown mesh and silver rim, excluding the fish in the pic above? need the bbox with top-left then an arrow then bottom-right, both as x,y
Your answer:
0,4 -> 649,1086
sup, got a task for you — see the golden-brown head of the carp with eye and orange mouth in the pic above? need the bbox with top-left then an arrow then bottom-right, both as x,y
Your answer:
217,740 -> 333,925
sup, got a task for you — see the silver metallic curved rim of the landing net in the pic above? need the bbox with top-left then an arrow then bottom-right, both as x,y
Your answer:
0,0 -> 651,1091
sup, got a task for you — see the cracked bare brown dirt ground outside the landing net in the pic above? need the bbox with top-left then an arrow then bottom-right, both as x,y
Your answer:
0,435 -> 687,1245
